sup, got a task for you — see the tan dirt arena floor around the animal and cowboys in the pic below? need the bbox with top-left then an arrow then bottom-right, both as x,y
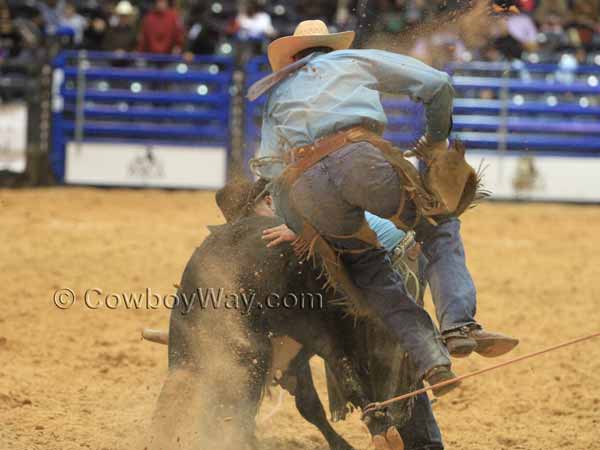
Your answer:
0,188 -> 600,450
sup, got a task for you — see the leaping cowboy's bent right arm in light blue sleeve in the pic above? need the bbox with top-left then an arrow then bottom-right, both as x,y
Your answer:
352,50 -> 454,142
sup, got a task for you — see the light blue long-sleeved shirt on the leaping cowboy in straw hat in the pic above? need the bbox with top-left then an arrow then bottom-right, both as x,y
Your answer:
258,50 -> 454,178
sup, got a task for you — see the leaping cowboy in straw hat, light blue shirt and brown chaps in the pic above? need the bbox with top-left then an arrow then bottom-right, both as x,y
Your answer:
249,21 -> 520,395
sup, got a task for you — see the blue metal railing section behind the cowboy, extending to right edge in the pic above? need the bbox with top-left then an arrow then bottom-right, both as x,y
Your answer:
246,57 -> 600,158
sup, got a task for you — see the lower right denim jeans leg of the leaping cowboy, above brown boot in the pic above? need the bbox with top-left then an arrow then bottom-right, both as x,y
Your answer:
423,218 -> 476,333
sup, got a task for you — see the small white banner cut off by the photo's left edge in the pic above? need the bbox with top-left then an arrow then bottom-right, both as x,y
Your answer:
0,103 -> 27,172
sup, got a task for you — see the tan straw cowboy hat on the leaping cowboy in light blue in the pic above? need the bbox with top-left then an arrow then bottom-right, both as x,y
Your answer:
268,20 -> 354,72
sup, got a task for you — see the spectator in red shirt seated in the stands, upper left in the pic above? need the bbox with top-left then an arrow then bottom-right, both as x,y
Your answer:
138,0 -> 184,54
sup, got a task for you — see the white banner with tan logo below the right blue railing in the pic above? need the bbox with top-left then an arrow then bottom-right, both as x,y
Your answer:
467,151 -> 600,202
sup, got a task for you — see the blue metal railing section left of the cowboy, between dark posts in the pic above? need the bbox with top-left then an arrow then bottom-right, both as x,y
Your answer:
51,51 -> 233,180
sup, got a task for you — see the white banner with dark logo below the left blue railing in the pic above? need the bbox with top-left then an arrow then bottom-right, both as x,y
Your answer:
65,142 -> 227,189
